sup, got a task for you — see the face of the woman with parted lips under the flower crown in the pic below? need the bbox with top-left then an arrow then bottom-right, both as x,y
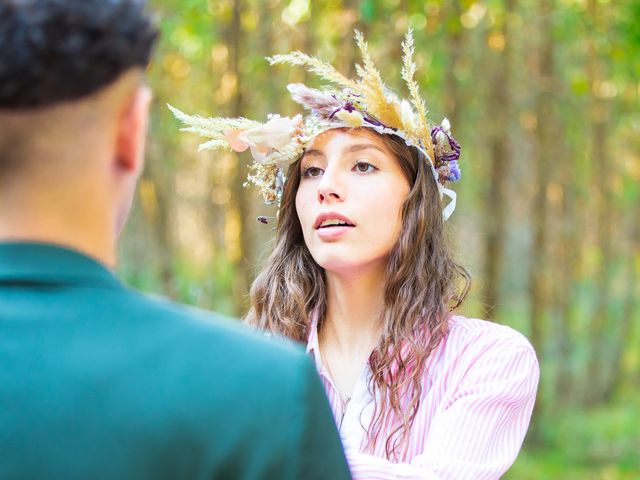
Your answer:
296,130 -> 410,273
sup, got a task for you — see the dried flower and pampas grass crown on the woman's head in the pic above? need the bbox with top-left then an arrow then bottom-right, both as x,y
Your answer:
168,30 -> 460,220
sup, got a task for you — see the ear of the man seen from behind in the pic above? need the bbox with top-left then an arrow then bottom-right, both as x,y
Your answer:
115,86 -> 151,172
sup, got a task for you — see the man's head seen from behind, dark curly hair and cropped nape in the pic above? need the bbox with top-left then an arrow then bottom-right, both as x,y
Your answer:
0,0 -> 157,262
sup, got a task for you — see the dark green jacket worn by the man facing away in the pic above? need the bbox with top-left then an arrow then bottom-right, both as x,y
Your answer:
0,243 -> 349,480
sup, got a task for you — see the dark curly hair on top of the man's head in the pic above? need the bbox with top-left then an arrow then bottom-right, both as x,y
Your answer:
0,0 -> 158,109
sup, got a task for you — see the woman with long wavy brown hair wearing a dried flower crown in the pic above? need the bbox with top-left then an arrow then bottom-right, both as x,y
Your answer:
176,32 -> 539,479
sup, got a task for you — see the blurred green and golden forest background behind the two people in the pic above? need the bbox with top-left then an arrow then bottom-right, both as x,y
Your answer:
120,0 -> 640,480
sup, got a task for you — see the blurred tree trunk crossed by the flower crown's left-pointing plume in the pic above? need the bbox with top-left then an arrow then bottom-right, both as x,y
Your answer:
225,0 -> 254,314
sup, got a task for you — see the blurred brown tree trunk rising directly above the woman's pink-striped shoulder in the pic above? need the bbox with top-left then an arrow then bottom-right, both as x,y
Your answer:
484,0 -> 516,318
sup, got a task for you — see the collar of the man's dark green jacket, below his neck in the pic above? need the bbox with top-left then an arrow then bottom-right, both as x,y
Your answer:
0,242 -> 124,288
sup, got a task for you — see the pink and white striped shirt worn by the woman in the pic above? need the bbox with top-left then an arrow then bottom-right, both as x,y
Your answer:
307,316 -> 540,480
